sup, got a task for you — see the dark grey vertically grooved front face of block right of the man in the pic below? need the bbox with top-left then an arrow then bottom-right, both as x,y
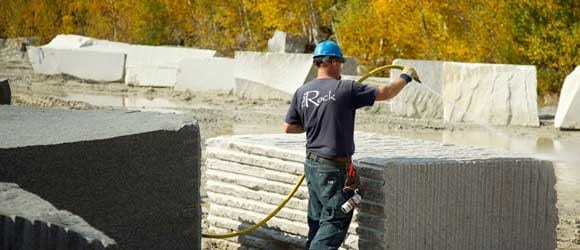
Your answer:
372,158 -> 558,249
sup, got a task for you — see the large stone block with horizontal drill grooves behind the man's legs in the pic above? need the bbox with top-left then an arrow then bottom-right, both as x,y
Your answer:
206,132 -> 558,250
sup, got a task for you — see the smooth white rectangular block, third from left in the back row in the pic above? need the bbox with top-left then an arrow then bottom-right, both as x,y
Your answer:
175,57 -> 235,91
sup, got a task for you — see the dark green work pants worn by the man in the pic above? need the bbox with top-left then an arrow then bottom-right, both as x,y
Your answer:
304,159 -> 353,250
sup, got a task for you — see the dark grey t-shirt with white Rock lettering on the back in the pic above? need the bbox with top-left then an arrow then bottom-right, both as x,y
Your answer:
285,78 -> 377,158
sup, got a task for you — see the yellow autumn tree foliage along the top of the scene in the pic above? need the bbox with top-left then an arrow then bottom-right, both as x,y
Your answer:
0,0 -> 580,94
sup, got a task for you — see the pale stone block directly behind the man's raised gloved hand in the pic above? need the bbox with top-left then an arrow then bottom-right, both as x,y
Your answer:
390,59 -> 444,119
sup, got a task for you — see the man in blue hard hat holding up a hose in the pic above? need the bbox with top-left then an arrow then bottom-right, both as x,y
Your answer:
284,41 -> 419,250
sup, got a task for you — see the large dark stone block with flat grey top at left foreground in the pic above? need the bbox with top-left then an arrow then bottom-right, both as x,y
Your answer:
0,106 -> 201,249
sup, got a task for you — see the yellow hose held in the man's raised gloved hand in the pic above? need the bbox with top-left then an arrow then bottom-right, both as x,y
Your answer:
201,65 -> 403,239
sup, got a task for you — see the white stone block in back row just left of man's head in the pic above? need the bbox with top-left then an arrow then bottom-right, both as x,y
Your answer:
234,51 -> 316,98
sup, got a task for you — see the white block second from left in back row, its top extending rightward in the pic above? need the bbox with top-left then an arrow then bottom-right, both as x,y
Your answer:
125,45 -> 216,87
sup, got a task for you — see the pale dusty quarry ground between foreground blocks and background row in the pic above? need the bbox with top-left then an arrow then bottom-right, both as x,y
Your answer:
0,58 -> 580,250
